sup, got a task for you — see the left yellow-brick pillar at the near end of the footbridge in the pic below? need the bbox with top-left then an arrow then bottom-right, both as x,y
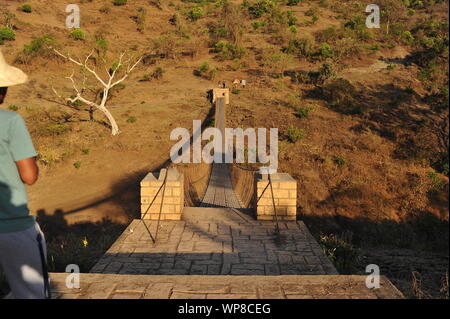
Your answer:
141,168 -> 184,220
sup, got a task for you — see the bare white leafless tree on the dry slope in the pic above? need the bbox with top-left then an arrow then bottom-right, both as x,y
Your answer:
53,49 -> 142,135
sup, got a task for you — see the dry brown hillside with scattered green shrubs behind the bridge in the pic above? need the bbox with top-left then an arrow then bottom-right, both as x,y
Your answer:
0,0 -> 448,297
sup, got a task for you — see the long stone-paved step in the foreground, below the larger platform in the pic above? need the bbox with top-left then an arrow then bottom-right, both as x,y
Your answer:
50,273 -> 403,299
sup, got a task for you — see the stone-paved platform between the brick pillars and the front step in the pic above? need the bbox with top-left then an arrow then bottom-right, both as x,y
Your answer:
90,207 -> 337,275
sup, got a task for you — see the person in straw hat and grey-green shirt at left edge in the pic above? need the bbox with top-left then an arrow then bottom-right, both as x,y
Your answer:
0,51 -> 49,299
